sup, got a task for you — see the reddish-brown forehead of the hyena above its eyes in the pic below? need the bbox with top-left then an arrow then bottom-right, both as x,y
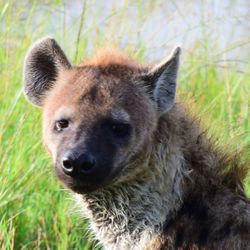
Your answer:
45,67 -> 145,116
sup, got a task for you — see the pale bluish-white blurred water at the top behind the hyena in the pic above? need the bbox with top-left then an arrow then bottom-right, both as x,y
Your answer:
52,0 -> 250,60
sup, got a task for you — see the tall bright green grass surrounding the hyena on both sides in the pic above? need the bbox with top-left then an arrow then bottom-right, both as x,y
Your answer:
0,0 -> 250,250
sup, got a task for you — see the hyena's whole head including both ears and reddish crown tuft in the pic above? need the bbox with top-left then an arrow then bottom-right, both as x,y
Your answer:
24,38 -> 180,194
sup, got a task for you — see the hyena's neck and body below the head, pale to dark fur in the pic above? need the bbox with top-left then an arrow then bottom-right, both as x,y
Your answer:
74,104 -> 250,250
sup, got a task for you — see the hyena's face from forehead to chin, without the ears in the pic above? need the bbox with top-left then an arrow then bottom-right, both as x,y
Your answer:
43,66 -> 156,192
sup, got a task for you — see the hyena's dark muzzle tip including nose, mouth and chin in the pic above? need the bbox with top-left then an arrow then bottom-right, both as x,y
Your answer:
55,148 -> 117,194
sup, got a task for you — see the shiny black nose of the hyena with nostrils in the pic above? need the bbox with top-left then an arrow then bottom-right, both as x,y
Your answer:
61,152 -> 96,175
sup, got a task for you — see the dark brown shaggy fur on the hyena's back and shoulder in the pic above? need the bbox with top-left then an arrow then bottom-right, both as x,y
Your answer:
147,104 -> 250,249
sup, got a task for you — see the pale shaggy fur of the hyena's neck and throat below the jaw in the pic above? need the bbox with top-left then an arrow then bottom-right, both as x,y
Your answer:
77,140 -> 183,249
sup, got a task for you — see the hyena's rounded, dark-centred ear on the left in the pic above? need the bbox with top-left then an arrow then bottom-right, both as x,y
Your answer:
23,38 -> 71,106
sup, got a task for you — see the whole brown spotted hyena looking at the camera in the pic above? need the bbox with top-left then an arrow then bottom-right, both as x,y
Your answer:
24,38 -> 250,249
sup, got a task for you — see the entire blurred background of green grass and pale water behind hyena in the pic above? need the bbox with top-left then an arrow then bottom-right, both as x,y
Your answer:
0,0 -> 250,250
